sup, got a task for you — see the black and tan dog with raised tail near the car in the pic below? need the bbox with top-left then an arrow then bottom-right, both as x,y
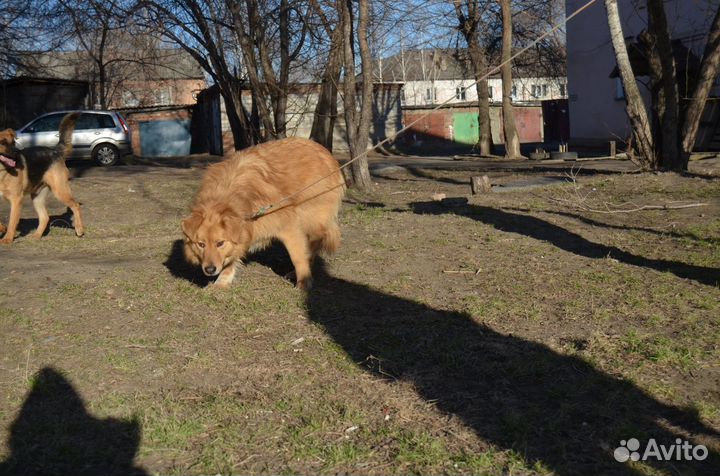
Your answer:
0,112 -> 85,244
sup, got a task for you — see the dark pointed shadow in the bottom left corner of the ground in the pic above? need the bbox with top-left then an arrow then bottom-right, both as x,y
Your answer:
0,368 -> 147,476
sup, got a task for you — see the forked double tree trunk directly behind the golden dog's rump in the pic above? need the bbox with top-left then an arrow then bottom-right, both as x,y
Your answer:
340,0 -> 373,190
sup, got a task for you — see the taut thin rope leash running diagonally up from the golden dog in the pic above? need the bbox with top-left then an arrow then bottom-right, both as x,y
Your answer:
251,0 -> 597,219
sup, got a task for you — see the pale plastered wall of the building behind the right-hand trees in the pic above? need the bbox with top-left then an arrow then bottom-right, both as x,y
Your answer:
566,0 -> 717,140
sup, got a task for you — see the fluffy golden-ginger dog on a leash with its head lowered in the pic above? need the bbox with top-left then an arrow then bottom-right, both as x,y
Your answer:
182,138 -> 345,289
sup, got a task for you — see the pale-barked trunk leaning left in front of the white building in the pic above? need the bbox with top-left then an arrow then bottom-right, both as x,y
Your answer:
605,0 -> 657,169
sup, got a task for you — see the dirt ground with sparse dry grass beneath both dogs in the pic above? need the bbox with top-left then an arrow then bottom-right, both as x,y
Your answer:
0,154 -> 720,475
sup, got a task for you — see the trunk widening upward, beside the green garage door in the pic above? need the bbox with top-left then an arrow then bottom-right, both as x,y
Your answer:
453,0 -> 493,155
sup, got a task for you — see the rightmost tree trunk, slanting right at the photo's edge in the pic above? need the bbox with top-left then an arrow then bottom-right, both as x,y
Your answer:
681,7 -> 720,165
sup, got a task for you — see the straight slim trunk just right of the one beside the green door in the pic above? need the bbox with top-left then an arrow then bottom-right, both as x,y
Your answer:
498,0 -> 522,159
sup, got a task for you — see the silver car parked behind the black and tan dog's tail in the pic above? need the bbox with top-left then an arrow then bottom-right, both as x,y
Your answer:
15,111 -> 132,166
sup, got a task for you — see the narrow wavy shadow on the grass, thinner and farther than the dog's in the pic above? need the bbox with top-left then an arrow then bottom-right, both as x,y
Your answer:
410,202 -> 720,286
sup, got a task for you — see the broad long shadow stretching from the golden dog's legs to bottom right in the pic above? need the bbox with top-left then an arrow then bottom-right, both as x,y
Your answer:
307,263 -> 720,476
